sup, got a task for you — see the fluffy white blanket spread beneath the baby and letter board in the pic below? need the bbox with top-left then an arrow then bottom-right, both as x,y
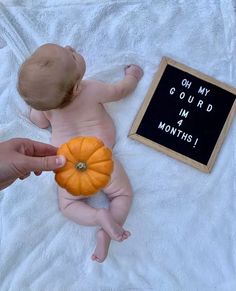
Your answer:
0,0 -> 236,291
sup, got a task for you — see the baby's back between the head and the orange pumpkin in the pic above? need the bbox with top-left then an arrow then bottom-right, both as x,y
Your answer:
46,81 -> 115,148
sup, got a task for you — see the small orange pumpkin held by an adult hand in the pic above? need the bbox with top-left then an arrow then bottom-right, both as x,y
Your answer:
55,136 -> 113,196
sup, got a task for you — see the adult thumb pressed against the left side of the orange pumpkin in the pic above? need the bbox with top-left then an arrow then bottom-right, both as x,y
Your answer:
25,155 -> 66,171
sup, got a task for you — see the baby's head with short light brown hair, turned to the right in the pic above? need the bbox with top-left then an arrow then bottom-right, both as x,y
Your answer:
18,44 -> 86,111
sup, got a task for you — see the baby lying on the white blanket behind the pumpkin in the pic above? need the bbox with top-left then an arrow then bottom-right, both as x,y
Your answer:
18,44 -> 143,262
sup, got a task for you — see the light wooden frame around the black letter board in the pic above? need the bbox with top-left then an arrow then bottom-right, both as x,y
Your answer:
128,57 -> 236,173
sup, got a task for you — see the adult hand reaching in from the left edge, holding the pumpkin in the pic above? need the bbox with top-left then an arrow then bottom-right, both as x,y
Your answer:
0,138 -> 66,190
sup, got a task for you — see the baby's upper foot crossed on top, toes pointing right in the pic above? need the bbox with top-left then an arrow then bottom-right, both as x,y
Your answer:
97,209 -> 130,242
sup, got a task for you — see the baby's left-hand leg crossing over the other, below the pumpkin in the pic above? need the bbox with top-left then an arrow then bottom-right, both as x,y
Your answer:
58,188 -> 124,241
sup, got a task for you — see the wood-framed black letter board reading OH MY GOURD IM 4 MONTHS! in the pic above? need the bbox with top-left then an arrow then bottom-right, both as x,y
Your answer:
129,57 -> 236,172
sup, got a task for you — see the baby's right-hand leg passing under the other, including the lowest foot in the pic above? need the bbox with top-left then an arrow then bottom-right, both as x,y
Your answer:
92,160 -> 132,262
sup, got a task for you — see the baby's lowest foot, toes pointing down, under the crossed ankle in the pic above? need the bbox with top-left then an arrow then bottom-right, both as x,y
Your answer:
91,229 -> 111,263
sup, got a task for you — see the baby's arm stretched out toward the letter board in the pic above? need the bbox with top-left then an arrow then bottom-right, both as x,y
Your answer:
92,65 -> 143,103
